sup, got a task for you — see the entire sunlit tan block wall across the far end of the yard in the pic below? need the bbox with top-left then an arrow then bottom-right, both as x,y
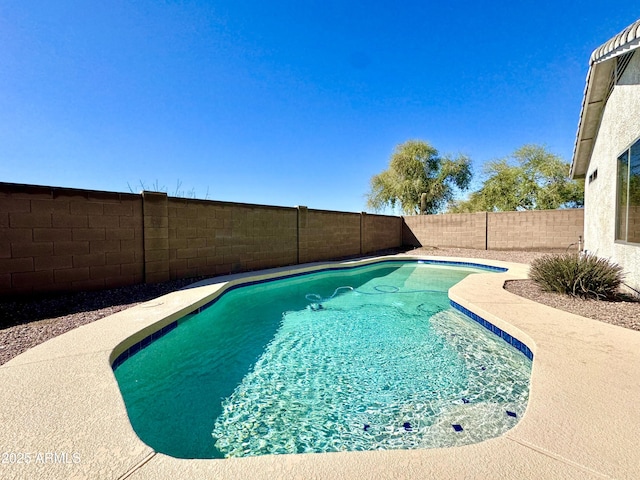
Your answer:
403,208 -> 584,250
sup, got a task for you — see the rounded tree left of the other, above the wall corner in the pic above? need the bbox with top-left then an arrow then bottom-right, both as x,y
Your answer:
367,140 -> 471,214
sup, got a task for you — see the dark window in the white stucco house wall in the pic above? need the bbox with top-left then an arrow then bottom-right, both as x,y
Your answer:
616,140 -> 640,243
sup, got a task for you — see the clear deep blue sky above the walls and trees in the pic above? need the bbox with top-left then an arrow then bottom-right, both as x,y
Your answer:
0,0 -> 640,211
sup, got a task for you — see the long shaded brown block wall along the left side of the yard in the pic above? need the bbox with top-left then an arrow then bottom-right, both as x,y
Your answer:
0,183 -> 402,296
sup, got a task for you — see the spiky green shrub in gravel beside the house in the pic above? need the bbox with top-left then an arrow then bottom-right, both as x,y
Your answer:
529,253 -> 623,299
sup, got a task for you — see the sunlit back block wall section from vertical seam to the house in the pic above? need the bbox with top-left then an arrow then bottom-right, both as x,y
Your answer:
487,208 -> 584,250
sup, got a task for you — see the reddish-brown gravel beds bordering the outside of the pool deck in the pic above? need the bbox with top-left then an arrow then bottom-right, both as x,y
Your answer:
0,248 -> 640,365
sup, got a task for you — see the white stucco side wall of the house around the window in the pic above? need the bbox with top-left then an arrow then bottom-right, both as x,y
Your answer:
584,51 -> 640,290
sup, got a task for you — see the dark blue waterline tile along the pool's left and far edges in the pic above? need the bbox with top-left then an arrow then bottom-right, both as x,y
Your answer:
111,259 -> 508,370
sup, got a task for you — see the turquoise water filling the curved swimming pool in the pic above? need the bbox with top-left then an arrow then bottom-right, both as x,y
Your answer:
115,262 -> 531,458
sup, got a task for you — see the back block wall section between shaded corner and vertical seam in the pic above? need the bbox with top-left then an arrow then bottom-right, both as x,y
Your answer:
403,212 -> 487,250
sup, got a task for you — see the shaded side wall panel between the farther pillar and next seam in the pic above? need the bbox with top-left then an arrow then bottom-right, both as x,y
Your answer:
298,207 -> 362,263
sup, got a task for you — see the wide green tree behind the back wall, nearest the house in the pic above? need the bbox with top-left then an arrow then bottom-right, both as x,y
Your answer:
449,145 -> 584,213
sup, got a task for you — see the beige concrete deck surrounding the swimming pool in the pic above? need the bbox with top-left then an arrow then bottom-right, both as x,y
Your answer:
0,255 -> 640,480
